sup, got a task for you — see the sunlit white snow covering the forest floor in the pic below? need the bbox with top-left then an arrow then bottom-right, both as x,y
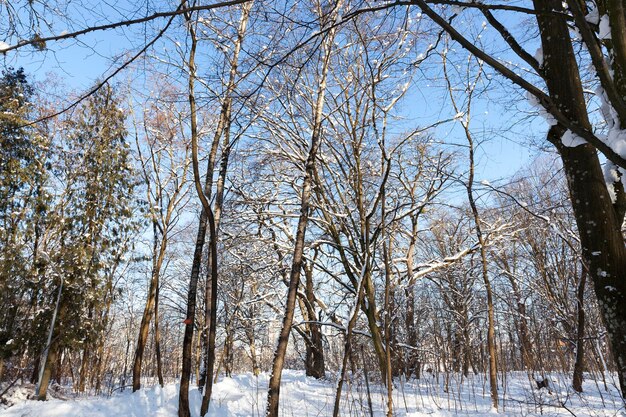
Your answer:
0,371 -> 626,417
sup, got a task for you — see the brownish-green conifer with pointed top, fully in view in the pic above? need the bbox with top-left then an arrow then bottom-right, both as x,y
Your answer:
40,86 -> 137,398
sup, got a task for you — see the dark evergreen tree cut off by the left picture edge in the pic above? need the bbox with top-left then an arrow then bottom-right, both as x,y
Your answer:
0,68 -> 50,379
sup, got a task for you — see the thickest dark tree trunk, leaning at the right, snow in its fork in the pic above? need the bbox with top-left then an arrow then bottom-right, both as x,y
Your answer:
534,0 -> 626,398
